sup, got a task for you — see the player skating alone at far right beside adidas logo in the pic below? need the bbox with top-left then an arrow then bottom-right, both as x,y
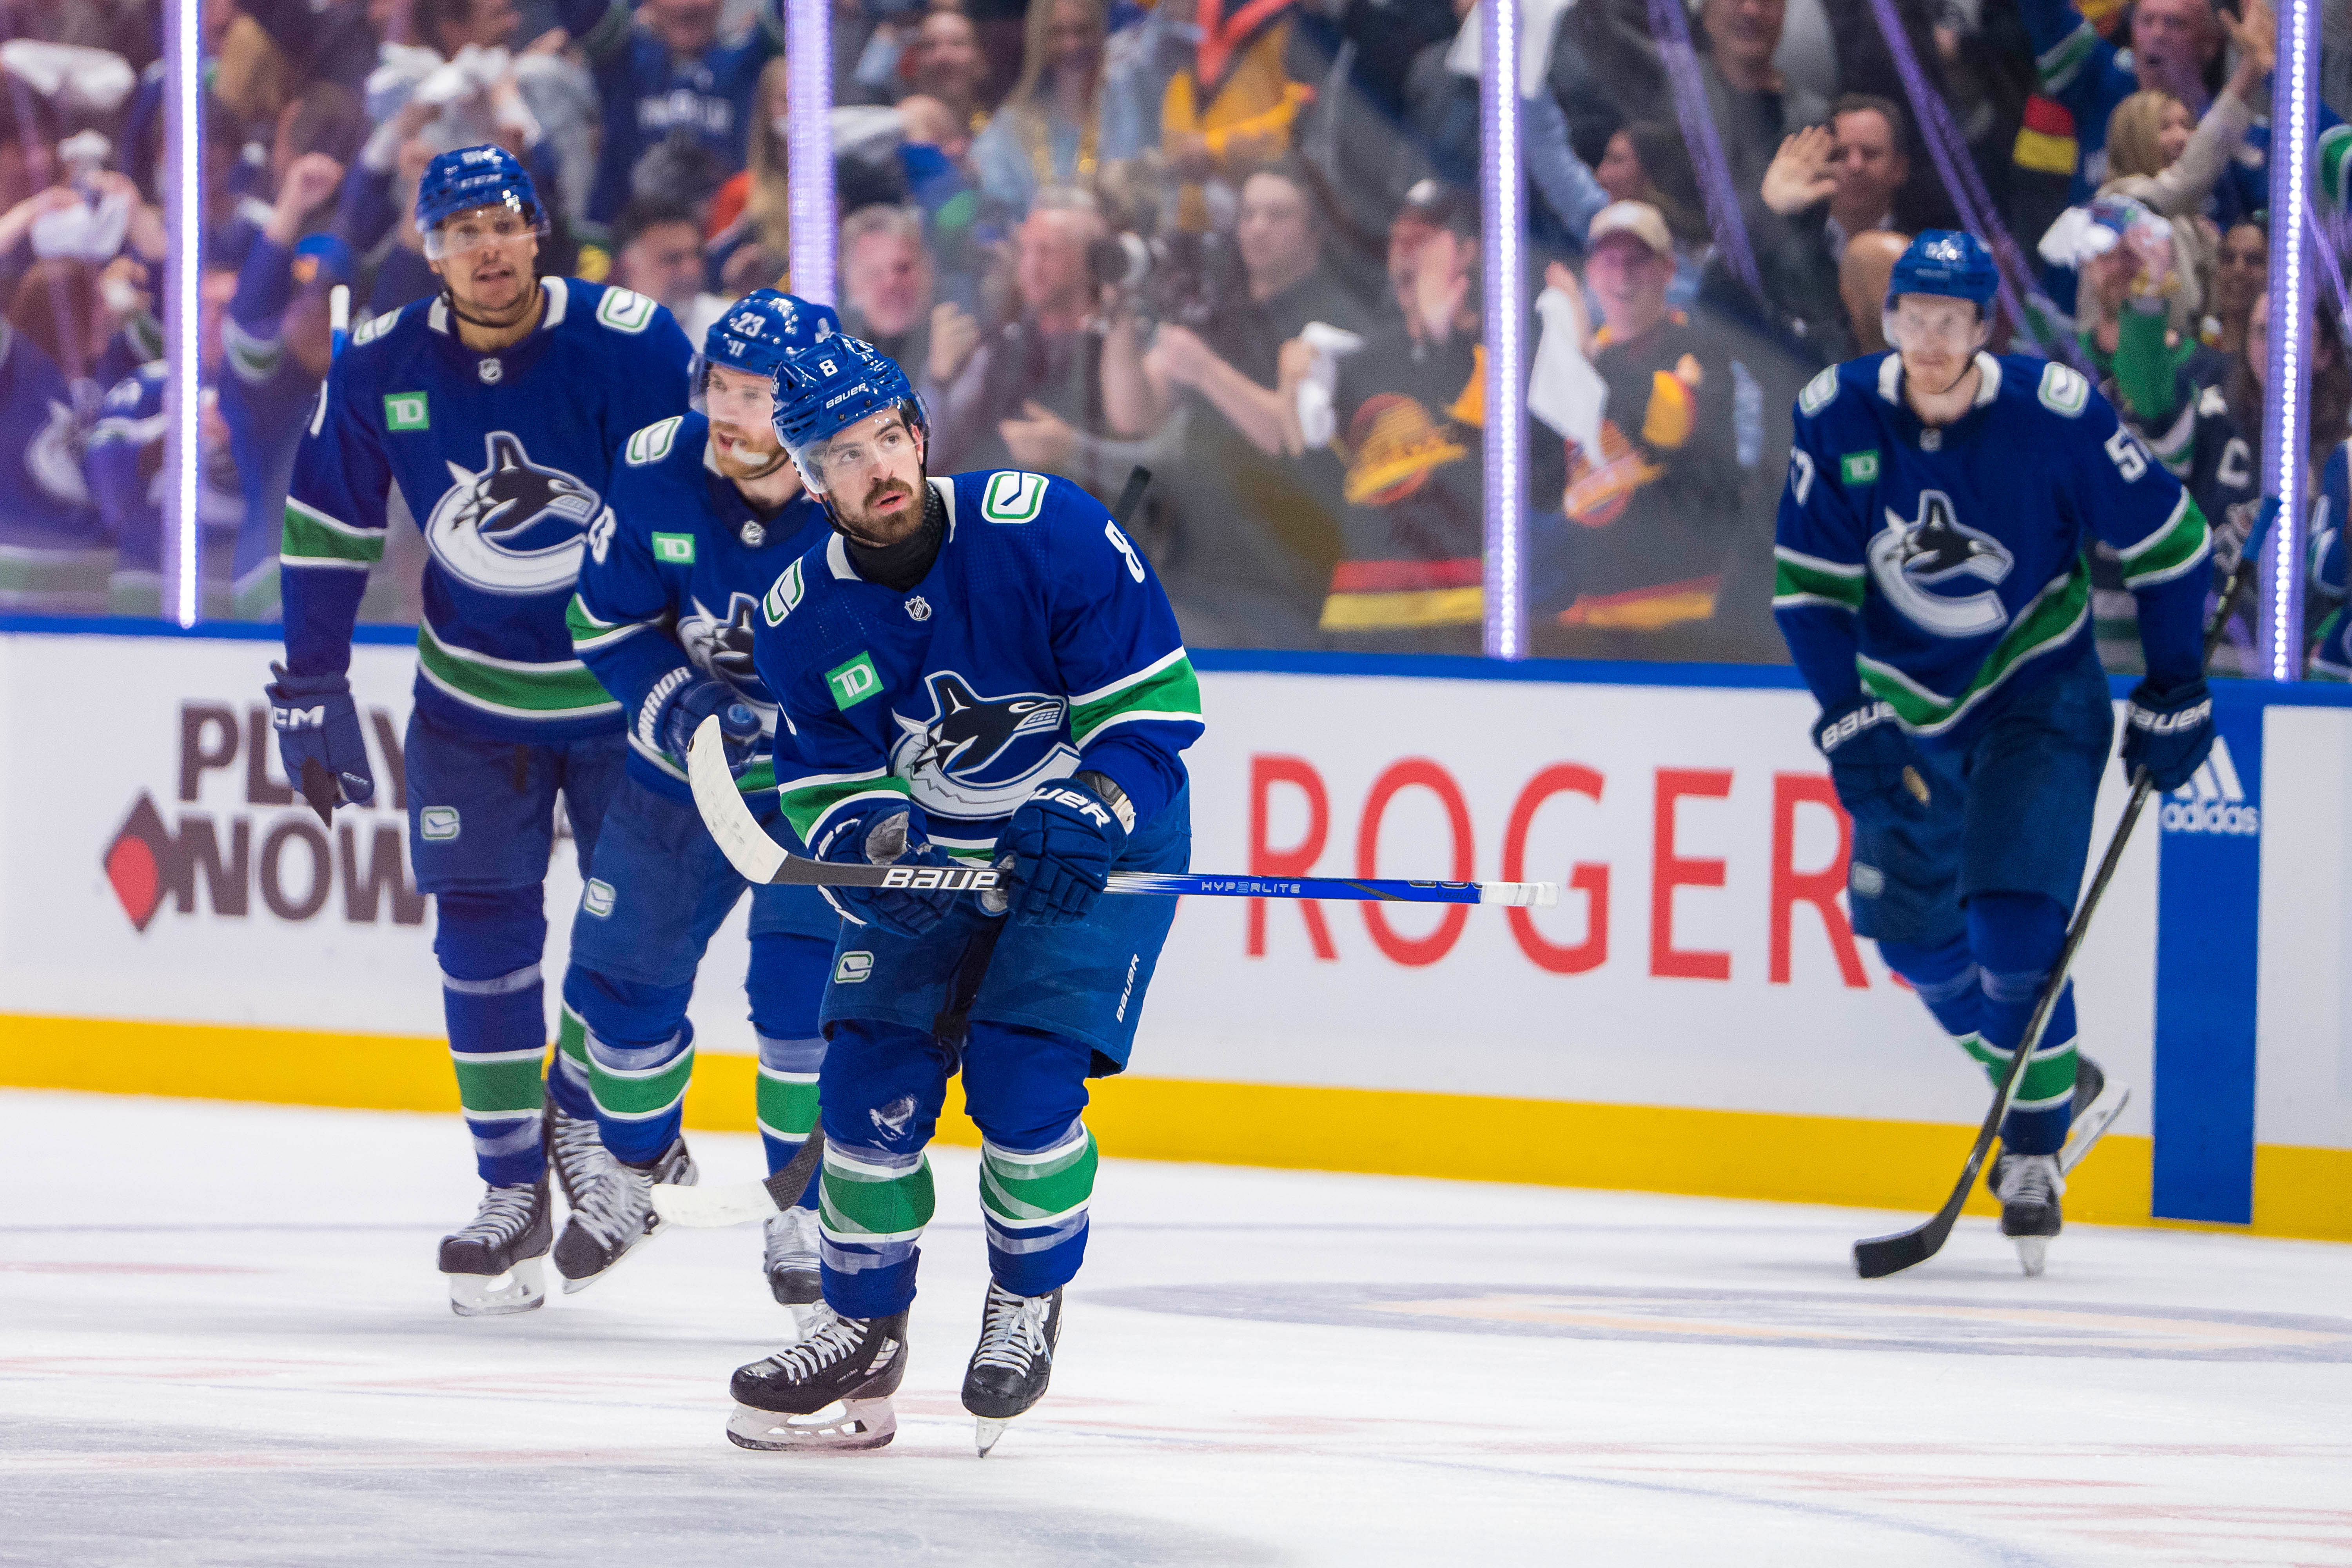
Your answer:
1773,230 -> 2213,1274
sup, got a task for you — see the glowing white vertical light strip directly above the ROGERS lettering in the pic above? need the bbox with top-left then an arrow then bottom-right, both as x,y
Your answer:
1477,0 -> 1526,658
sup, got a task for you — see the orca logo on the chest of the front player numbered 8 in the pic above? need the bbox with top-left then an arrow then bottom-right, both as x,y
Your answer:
889,670 -> 1077,818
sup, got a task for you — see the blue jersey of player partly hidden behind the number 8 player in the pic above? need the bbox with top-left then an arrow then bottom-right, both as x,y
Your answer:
567,414 -> 833,799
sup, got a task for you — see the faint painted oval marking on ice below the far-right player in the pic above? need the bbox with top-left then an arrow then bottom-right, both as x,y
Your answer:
1087,1283 -> 2352,1361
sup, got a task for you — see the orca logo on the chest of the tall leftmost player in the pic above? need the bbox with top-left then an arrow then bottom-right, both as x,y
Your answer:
426,430 -> 597,592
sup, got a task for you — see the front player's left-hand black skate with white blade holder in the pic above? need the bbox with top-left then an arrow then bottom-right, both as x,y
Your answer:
727,1302 -> 906,1453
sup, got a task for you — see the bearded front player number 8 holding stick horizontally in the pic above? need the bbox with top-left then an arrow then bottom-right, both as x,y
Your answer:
727,339 -> 1200,1453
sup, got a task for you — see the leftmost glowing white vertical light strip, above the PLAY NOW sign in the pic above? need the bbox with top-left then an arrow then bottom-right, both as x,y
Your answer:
162,5 -> 205,625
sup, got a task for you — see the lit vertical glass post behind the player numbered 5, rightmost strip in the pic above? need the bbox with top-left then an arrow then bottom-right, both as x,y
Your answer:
2260,0 -> 2319,682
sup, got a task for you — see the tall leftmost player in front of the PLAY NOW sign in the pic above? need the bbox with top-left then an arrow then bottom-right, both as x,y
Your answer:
268,146 -> 691,1316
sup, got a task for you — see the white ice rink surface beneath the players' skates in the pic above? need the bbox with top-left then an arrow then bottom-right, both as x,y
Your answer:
0,1091 -> 2352,1568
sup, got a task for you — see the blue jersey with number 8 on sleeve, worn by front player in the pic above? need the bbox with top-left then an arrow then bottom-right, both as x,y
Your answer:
753,470 -> 1202,856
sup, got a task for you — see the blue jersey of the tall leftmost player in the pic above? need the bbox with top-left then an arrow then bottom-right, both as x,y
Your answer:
280,278 -> 691,740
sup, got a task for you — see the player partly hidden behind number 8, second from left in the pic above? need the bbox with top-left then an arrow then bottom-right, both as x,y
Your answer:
555,289 -> 840,1307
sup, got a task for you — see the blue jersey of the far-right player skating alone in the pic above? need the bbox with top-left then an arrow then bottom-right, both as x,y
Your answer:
1773,353 -> 2211,738
